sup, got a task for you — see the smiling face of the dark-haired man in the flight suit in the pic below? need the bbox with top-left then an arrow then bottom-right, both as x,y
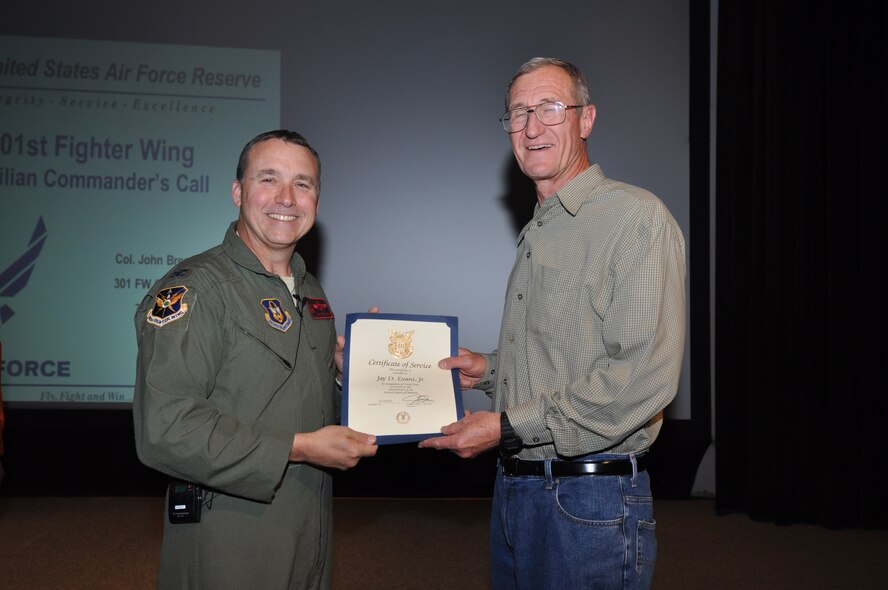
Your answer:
231,139 -> 320,276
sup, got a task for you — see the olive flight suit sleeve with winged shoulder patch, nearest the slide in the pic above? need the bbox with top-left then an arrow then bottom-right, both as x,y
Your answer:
133,283 -> 295,502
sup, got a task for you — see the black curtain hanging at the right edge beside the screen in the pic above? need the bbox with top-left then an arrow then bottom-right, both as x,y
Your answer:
715,0 -> 888,528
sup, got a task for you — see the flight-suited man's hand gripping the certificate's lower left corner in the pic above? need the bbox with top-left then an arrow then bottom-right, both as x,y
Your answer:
290,426 -> 379,470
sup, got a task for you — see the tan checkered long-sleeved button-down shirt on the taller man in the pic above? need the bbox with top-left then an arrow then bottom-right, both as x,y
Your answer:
479,165 -> 685,459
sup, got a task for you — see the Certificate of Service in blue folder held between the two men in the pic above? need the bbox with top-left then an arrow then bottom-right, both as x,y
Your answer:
342,313 -> 463,445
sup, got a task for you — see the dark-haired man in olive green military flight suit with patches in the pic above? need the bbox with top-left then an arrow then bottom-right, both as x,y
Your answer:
133,130 -> 377,590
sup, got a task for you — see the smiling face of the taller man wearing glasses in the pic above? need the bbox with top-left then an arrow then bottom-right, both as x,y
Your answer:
508,66 -> 595,202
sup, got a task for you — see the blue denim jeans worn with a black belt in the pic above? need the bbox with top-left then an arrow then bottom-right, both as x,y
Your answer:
490,454 -> 657,590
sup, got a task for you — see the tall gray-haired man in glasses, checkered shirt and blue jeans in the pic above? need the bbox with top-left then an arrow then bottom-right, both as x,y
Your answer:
420,58 -> 685,590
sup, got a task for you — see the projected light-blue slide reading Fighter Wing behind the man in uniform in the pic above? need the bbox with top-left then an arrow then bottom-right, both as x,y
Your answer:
0,37 -> 280,407
